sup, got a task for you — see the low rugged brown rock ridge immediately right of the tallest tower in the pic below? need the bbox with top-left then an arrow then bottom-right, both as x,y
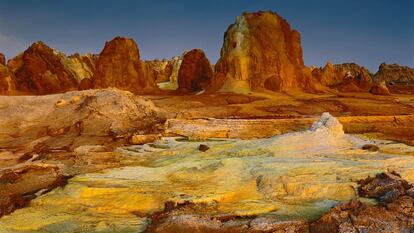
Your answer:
312,62 -> 373,92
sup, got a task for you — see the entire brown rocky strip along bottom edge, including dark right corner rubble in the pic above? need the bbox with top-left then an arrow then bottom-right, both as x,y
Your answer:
146,173 -> 414,233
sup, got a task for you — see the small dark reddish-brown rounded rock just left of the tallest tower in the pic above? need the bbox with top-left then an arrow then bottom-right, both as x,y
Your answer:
178,49 -> 214,92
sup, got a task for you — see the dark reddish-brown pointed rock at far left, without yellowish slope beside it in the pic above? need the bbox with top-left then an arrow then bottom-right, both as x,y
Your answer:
8,41 -> 77,94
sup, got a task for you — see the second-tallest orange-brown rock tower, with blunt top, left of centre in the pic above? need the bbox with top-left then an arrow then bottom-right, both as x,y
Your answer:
92,37 -> 157,94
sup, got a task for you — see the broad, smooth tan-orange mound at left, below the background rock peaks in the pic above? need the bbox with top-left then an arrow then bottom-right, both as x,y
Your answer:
0,89 -> 165,152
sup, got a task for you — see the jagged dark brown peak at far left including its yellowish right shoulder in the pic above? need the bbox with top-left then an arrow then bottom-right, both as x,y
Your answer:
8,41 -> 93,94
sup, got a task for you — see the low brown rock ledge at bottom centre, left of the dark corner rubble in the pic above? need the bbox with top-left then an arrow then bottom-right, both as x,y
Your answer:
146,202 -> 309,233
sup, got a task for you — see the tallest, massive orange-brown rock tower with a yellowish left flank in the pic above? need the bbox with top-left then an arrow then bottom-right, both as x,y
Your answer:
211,12 -> 323,92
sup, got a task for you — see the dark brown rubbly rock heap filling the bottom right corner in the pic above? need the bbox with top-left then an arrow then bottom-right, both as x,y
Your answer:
310,173 -> 414,233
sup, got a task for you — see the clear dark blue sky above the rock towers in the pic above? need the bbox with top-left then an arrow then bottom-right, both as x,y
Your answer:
0,0 -> 414,72
